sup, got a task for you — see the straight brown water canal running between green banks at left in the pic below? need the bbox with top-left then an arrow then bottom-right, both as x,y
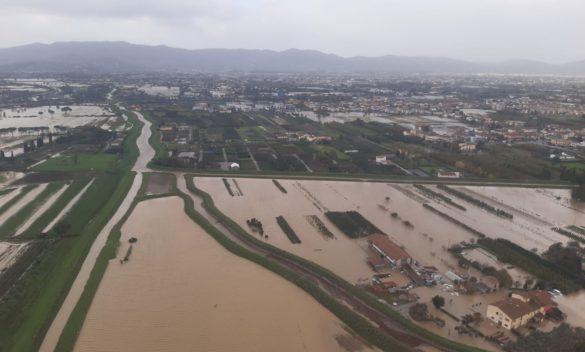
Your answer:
39,113 -> 155,352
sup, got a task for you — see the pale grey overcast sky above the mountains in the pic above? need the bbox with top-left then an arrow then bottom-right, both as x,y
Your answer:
0,0 -> 585,63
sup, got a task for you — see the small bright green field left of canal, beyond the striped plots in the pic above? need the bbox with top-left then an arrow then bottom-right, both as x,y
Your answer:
32,153 -> 118,171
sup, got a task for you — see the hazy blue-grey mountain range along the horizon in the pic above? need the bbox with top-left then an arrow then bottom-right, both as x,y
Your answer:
0,42 -> 585,75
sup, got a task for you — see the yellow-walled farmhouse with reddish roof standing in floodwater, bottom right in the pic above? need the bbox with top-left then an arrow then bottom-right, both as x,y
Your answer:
486,291 -> 556,330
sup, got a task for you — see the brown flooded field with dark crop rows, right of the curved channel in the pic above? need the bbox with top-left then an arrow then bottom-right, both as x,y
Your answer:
195,178 -> 585,280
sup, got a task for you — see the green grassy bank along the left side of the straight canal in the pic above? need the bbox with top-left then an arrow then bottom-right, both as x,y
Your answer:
0,108 -> 141,351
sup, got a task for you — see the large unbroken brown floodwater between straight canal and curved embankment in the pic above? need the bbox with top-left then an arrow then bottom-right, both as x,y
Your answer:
75,197 -> 369,352
